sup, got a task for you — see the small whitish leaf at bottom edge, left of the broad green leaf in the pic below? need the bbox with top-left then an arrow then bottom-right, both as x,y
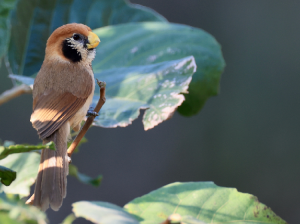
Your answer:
72,201 -> 139,224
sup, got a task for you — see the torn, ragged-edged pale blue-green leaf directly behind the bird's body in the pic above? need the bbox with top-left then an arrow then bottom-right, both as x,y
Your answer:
10,57 -> 196,130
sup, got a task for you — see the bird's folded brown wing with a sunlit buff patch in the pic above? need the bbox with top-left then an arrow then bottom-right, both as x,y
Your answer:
30,90 -> 87,139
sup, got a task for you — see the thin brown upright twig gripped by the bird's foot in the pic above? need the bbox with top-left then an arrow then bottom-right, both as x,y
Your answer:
68,79 -> 106,158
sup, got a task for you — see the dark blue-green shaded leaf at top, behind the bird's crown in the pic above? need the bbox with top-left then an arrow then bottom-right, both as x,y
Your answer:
8,0 -> 166,76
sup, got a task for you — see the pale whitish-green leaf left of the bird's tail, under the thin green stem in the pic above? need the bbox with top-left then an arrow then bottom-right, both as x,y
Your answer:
0,152 -> 40,196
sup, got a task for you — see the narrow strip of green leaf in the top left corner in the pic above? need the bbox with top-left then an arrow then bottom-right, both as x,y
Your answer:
0,0 -> 17,65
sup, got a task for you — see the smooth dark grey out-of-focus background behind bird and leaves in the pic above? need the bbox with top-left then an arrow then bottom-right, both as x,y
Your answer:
0,0 -> 300,224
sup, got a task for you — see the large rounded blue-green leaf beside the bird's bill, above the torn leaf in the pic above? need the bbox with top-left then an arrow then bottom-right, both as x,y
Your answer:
93,22 -> 225,115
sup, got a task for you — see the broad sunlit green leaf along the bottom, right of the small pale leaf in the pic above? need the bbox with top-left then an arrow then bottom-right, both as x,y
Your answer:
124,182 -> 286,224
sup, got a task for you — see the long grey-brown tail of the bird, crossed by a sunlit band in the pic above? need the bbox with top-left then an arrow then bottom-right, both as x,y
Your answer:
27,122 -> 70,211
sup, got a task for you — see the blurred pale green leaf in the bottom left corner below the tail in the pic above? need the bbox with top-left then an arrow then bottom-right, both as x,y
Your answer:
0,194 -> 47,224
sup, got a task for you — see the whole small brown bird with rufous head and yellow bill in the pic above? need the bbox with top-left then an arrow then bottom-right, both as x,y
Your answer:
27,23 -> 100,211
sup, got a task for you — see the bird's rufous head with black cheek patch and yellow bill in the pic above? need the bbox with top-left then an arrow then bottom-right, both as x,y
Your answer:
45,23 -> 100,64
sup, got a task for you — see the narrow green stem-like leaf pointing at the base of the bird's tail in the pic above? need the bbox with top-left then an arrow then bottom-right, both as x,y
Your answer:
0,142 -> 55,160
